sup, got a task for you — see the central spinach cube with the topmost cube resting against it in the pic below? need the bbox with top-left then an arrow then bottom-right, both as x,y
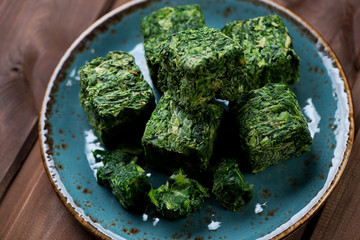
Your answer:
142,93 -> 223,172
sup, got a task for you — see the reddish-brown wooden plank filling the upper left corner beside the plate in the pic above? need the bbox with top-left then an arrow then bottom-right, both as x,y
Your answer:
0,0 -> 112,199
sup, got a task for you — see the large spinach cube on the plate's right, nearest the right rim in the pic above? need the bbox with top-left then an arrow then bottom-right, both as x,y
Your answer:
231,83 -> 312,173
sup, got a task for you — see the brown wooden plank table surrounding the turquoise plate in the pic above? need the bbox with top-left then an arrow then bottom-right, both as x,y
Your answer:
0,0 -> 360,240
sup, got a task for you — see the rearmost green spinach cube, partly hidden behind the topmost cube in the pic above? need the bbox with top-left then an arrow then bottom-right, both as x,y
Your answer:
140,4 -> 205,86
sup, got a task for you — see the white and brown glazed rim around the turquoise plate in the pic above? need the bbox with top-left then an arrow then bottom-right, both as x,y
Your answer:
38,0 -> 355,240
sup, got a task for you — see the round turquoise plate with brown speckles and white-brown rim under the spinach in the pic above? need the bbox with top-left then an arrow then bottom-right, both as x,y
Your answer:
39,0 -> 354,239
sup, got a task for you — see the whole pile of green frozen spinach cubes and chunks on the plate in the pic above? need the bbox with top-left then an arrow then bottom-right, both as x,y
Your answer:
80,5 -> 312,219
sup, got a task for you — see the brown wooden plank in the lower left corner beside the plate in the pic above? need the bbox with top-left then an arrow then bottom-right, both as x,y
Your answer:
0,144 -> 95,240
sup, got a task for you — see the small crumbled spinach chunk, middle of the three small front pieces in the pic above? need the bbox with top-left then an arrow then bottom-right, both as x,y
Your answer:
149,170 -> 209,219
